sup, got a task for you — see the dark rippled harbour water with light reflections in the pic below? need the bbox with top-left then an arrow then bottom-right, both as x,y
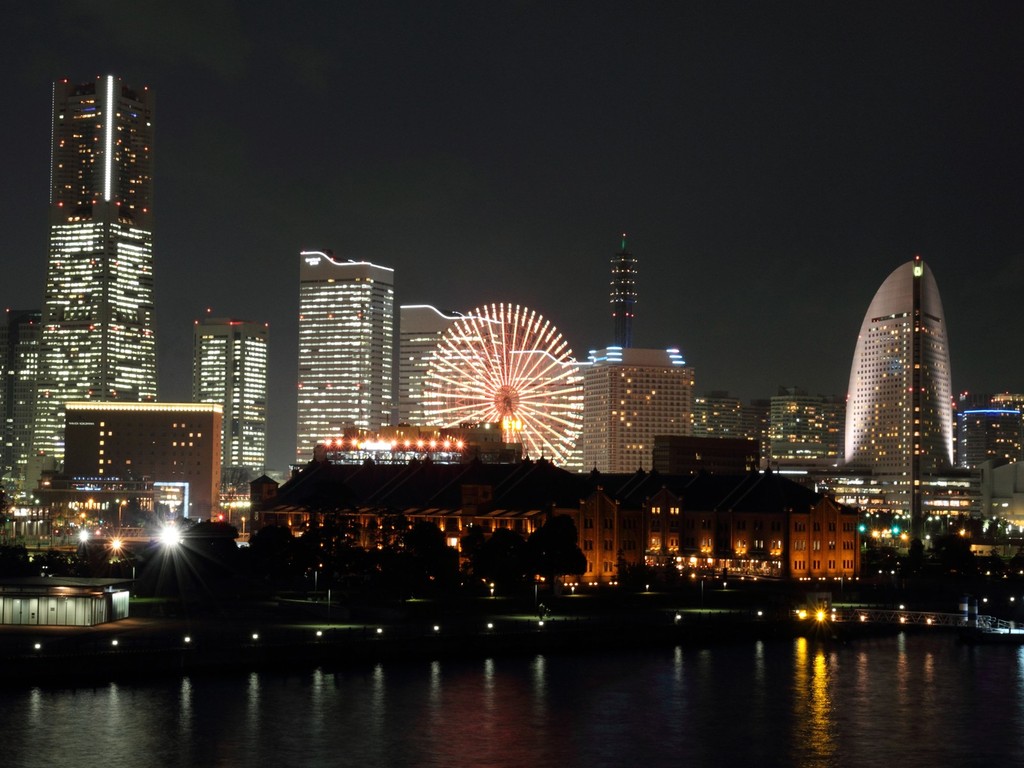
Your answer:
0,635 -> 1024,768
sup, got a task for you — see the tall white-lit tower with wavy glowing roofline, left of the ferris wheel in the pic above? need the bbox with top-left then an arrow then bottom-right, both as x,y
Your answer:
296,251 -> 394,463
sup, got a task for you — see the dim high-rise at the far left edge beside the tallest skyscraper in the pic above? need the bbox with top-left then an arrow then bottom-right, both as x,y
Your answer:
0,309 -> 41,487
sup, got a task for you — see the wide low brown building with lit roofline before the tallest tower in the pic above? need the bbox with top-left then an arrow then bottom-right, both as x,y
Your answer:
58,401 -> 223,519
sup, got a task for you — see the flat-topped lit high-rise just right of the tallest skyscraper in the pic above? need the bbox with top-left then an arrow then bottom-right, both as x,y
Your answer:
193,317 -> 267,476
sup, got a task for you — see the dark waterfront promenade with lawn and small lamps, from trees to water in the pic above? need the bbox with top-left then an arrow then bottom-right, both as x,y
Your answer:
0,590 -> 974,686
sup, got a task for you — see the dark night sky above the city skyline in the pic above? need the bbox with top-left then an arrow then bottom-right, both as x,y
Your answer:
0,0 -> 1024,468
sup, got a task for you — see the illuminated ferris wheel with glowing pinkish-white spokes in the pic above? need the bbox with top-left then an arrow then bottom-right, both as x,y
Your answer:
423,304 -> 583,466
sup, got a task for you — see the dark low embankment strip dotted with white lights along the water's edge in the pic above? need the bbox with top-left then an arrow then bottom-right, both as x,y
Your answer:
0,614 -> 799,686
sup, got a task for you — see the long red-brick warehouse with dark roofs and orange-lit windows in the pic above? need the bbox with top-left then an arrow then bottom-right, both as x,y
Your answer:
255,460 -> 860,584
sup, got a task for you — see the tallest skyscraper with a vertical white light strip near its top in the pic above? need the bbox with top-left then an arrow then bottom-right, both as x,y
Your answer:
34,75 -> 157,468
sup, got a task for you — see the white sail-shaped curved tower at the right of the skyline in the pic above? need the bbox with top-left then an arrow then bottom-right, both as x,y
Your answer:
846,256 -> 953,536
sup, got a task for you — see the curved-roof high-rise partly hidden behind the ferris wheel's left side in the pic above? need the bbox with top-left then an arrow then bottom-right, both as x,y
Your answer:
398,304 -> 463,425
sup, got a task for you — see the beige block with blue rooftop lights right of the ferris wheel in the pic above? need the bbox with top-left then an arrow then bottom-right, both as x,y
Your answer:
581,347 -> 693,472
